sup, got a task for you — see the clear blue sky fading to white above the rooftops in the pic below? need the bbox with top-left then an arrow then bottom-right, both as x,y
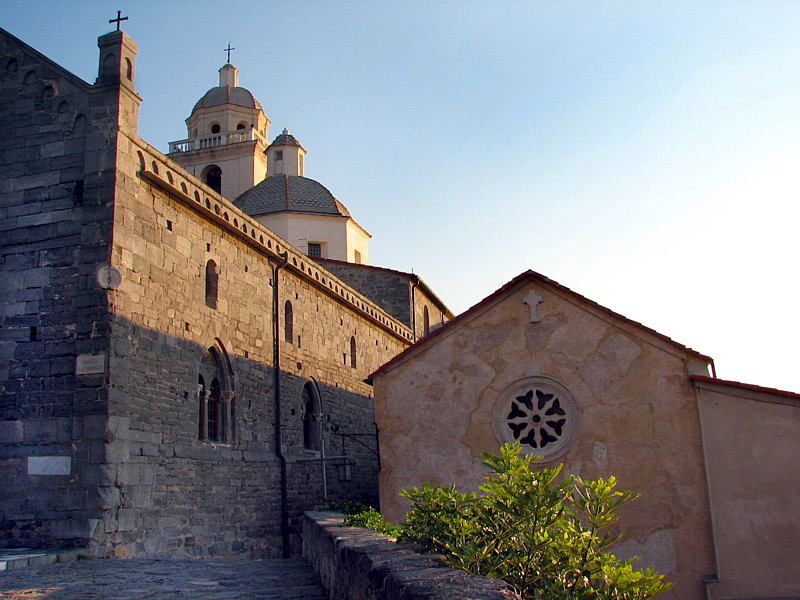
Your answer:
6,0 -> 800,392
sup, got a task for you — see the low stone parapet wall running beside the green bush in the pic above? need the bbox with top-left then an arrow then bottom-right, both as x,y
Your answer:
303,512 -> 519,600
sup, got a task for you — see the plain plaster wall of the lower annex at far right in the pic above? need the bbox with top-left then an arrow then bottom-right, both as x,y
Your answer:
698,386 -> 800,597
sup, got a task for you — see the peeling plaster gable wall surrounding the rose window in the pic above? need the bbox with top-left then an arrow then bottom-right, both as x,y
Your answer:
375,283 -> 714,598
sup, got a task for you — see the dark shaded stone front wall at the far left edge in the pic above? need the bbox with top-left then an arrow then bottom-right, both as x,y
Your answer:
0,30 -> 122,546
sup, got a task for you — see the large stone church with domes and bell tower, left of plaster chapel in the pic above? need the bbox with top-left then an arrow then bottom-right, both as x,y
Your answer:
0,25 -> 452,557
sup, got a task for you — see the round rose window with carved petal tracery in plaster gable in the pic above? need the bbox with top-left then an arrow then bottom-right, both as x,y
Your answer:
492,377 -> 580,460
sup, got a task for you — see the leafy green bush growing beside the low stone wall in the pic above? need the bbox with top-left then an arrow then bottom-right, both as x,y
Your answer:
398,443 -> 671,600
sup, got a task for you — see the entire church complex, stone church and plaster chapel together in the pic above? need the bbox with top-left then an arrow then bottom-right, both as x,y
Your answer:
0,18 -> 800,599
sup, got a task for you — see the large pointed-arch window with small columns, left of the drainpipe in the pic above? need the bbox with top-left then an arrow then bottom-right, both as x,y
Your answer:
197,341 -> 236,442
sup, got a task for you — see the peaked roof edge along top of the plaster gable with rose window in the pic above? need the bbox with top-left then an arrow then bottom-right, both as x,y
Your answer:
368,269 -> 712,381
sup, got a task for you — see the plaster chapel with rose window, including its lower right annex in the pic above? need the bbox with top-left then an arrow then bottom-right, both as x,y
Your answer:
372,271 -> 800,600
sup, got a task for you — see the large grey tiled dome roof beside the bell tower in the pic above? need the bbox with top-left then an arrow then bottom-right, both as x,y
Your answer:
233,175 -> 350,217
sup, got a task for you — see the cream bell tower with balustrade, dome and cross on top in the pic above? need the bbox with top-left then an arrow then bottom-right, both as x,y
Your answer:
168,62 -> 269,200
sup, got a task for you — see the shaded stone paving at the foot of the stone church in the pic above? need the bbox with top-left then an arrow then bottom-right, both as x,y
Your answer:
0,559 -> 324,600
